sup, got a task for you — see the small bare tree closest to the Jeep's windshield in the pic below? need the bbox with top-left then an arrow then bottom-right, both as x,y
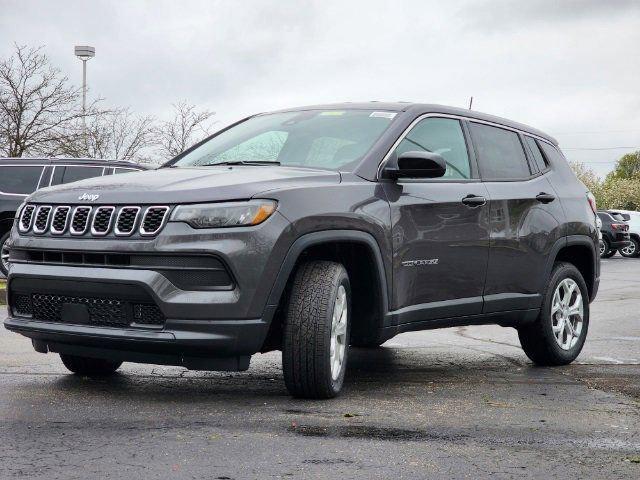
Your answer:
156,101 -> 215,159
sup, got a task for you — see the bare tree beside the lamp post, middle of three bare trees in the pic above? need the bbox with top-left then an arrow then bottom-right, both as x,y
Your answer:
57,108 -> 155,163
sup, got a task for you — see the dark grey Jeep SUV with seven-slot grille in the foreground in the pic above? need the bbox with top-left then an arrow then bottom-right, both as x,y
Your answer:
5,103 -> 600,398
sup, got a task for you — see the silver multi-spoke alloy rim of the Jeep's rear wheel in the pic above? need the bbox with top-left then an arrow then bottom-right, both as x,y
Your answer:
551,278 -> 584,350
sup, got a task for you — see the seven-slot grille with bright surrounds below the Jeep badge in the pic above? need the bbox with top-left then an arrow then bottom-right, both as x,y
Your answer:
18,205 -> 170,236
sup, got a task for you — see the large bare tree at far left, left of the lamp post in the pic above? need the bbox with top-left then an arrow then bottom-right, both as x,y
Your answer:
0,45 -> 94,157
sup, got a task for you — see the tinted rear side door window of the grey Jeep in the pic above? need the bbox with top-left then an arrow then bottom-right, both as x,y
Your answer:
470,122 -> 531,180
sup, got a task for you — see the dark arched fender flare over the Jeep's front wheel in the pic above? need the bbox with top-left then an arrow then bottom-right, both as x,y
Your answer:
265,230 -> 389,318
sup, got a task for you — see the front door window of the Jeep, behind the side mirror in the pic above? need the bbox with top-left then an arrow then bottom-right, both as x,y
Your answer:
396,118 -> 471,180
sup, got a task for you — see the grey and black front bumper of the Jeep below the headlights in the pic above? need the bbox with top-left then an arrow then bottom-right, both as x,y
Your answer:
5,215 -> 290,370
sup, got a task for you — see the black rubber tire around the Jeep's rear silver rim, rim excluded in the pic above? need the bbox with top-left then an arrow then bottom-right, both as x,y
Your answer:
540,264 -> 590,363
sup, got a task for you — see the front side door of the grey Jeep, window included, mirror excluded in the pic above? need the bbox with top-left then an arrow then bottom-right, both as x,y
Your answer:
384,117 -> 489,323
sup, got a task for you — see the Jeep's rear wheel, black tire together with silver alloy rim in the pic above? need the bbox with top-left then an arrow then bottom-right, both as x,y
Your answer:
518,262 -> 589,366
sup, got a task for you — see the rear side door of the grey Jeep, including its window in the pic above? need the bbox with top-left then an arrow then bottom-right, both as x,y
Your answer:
469,121 -> 564,313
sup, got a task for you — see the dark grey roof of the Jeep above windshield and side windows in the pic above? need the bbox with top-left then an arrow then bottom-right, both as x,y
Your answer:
268,102 -> 558,145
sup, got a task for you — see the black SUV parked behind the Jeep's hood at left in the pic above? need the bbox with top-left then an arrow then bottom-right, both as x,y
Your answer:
0,158 -> 144,275
